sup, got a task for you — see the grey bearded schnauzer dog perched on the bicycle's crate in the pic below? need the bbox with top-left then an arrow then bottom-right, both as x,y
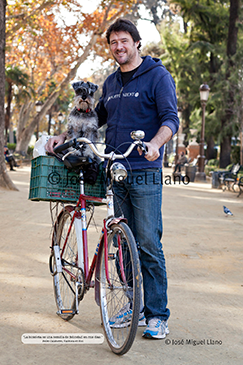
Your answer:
67,81 -> 98,159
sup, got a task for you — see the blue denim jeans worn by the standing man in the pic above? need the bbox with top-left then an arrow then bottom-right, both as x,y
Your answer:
113,168 -> 170,321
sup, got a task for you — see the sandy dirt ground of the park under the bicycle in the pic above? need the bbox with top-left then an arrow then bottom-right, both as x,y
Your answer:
0,167 -> 243,365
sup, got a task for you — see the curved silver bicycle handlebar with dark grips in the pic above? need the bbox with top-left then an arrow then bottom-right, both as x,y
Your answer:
53,130 -> 147,160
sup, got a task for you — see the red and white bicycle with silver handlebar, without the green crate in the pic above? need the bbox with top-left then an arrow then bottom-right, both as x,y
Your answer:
49,131 -> 146,355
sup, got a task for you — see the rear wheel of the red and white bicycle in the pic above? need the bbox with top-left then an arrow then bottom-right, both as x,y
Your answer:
53,209 -> 84,321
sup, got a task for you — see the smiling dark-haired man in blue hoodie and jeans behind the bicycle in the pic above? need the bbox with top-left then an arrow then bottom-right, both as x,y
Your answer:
47,18 -> 179,339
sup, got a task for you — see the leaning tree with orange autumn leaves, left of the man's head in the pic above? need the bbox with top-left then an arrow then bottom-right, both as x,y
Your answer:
5,0 -> 134,153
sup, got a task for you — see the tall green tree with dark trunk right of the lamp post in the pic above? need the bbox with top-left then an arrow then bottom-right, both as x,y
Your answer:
165,0 -> 241,167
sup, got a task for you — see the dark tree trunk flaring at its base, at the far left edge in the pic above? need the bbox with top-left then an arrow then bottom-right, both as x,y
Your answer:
0,0 -> 18,190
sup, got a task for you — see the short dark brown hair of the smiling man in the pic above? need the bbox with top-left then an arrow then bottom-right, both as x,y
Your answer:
106,18 -> 142,49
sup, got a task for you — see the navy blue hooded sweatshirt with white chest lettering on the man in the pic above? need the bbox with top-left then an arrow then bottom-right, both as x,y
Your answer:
96,56 -> 179,170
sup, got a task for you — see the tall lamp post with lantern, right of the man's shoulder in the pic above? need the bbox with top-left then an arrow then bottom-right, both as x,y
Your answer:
196,83 -> 210,180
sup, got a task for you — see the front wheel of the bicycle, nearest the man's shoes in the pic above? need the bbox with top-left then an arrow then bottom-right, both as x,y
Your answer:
99,222 -> 141,355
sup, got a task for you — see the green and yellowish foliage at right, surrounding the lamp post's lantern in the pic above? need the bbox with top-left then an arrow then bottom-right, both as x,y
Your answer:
160,0 -> 243,166
